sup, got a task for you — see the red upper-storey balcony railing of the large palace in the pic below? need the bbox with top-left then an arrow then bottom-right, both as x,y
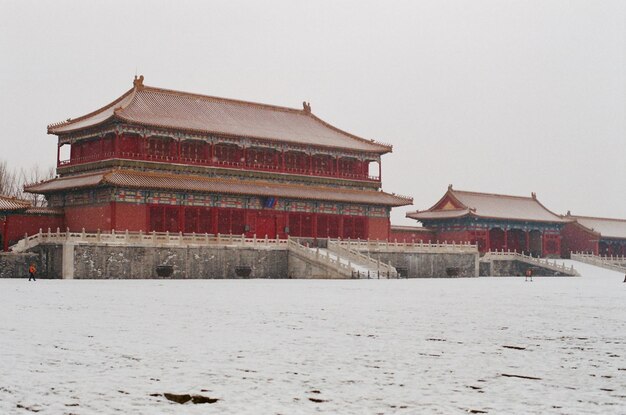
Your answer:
57,151 -> 380,182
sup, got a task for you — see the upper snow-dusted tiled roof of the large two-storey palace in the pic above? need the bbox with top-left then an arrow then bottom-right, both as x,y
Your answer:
48,76 -> 392,154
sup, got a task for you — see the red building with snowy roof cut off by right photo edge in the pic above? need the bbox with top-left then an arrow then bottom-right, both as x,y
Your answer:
561,211 -> 626,257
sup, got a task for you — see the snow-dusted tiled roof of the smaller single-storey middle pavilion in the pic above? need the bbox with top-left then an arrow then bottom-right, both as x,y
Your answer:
406,186 -> 571,223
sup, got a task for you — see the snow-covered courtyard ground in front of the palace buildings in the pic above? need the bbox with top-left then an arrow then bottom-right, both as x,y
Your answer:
0,264 -> 626,415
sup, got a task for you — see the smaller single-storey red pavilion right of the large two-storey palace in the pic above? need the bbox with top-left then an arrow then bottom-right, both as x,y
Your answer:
406,186 -> 568,256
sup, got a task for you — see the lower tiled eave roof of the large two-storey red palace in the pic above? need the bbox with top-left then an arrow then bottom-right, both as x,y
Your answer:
25,170 -> 413,206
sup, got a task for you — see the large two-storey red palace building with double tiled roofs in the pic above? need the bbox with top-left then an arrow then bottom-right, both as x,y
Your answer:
26,76 -> 412,239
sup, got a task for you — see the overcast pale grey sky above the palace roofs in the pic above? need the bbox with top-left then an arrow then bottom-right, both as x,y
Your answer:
0,0 -> 626,224
